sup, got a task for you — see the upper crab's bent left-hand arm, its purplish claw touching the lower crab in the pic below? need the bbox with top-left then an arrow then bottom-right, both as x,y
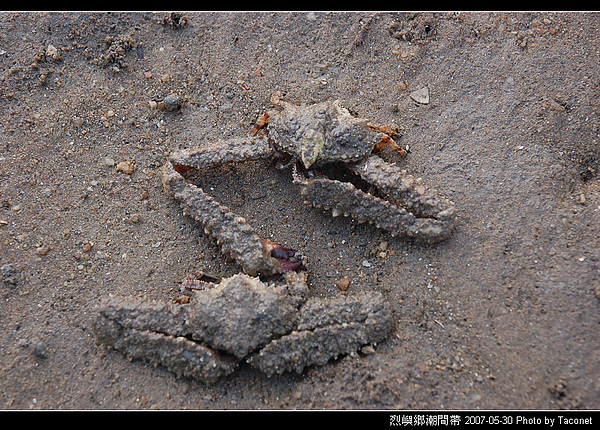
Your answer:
162,138 -> 302,276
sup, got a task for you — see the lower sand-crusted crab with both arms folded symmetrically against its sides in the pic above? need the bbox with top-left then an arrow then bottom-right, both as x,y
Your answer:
92,272 -> 393,385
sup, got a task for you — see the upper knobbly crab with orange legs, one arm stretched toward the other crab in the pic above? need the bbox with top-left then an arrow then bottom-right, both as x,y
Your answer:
162,95 -> 456,275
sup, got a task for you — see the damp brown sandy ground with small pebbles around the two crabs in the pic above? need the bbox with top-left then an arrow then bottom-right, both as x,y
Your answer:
0,12 -> 600,409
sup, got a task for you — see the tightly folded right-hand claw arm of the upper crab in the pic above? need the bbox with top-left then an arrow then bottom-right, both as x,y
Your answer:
294,155 -> 455,243
